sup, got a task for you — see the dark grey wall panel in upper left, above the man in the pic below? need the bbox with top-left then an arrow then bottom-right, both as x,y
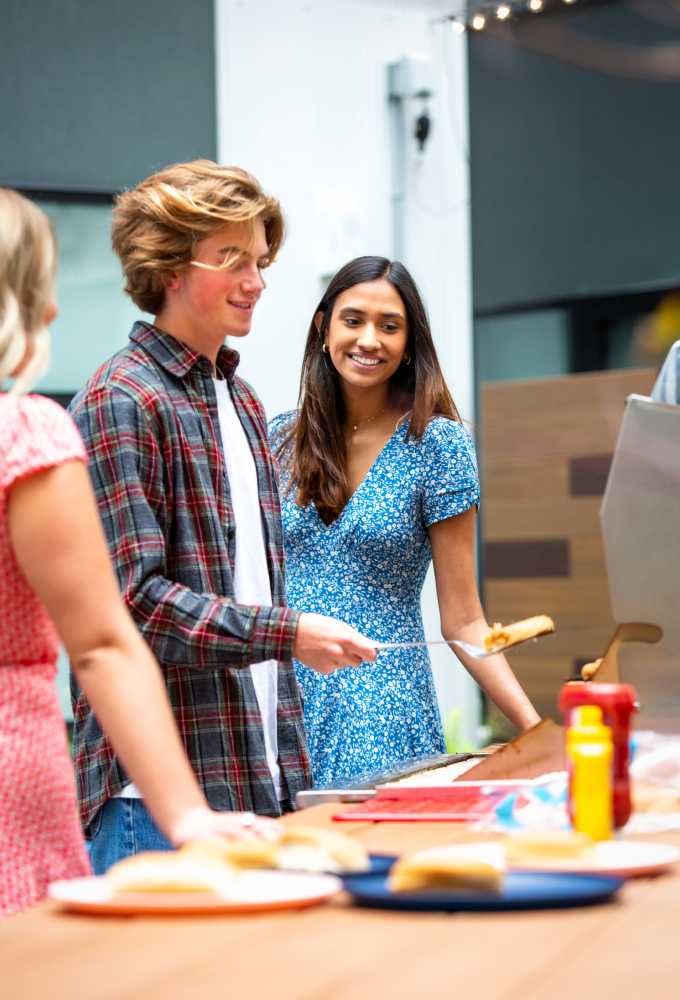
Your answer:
0,0 -> 217,192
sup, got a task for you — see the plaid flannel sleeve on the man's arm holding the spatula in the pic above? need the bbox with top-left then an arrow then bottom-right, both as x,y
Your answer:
69,387 -> 299,670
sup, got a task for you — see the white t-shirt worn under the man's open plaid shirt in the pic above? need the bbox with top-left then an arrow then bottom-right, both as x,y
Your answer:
118,379 -> 281,799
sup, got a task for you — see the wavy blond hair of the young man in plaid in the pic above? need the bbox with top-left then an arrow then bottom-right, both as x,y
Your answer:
111,160 -> 283,315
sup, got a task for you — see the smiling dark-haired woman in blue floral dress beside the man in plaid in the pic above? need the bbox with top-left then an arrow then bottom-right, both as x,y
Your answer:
271,257 -> 538,786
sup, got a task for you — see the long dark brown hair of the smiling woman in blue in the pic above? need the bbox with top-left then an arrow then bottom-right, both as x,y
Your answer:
276,257 -> 460,524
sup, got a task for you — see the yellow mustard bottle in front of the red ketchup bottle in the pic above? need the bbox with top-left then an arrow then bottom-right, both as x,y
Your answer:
567,705 -> 613,840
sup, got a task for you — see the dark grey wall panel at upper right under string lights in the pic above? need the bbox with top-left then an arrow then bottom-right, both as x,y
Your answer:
469,3 -> 680,312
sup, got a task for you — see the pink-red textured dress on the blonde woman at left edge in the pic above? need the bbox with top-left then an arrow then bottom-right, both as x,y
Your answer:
0,393 -> 90,916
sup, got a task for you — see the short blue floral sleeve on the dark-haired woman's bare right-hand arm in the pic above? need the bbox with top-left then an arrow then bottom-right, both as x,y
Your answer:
420,417 -> 479,528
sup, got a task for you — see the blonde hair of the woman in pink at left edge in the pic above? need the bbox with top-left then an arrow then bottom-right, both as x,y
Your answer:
0,188 -> 57,394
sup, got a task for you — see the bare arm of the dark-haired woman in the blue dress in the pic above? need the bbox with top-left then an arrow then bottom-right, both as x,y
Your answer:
428,508 -> 540,729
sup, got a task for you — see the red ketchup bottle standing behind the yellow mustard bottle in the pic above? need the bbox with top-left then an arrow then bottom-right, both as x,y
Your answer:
559,681 -> 638,829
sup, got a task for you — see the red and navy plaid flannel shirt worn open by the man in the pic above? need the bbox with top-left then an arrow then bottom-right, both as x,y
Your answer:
70,322 -> 310,834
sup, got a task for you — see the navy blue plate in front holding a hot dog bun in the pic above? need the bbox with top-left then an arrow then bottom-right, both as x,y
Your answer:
342,872 -> 623,912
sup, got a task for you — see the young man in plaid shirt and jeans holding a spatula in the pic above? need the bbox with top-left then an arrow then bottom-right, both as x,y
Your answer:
71,160 -> 375,872
